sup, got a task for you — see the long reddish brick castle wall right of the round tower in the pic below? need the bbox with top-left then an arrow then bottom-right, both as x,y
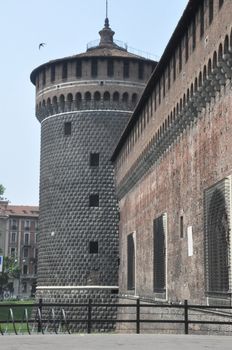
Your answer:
113,0 -> 232,303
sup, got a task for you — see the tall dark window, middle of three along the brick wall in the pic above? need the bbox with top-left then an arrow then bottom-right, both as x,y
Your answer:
153,214 -> 166,293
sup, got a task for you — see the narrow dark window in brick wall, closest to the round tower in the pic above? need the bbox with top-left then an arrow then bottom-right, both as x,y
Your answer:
127,233 -> 135,290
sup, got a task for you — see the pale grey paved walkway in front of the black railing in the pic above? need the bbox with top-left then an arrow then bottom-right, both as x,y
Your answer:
0,334 -> 232,350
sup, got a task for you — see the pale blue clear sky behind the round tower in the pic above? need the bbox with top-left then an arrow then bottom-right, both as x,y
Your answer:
0,0 -> 188,205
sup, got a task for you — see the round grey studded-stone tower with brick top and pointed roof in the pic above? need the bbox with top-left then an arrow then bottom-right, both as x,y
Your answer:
31,18 -> 155,322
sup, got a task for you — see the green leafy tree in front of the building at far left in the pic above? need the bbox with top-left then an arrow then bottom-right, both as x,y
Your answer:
0,256 -> 20,296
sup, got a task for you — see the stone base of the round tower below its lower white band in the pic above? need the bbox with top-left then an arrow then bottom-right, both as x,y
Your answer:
36,286 -> 118,333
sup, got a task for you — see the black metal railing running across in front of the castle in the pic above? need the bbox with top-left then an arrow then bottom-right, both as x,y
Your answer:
0,299 -> 232,335
